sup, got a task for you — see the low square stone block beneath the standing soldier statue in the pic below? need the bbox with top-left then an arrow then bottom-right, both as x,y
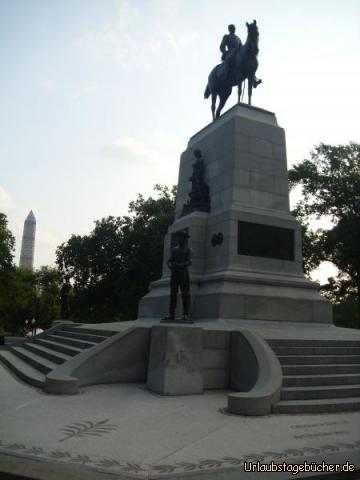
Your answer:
147,325 -> 203,395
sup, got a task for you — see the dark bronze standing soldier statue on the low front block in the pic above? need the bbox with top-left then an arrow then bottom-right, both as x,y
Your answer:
164,231 -> 192,322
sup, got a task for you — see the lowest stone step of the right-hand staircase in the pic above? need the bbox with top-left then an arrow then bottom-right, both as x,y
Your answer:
272,397 -> 360,414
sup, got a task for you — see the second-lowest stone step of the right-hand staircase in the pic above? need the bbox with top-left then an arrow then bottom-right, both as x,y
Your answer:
281,385 -> 360,400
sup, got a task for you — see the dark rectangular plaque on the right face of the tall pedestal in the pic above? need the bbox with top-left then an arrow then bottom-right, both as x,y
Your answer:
238,221 -> 295,261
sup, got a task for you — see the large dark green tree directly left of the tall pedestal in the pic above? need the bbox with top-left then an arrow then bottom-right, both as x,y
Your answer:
56,185 -> 175,321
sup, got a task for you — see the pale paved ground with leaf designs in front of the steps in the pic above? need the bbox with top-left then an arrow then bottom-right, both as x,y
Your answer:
0,365 -> 360,480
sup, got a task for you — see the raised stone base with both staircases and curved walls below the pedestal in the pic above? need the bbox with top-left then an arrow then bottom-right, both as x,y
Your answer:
0,319 -> 360,415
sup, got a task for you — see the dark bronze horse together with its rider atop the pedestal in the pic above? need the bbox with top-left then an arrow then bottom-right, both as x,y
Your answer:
204,20 -> 261,120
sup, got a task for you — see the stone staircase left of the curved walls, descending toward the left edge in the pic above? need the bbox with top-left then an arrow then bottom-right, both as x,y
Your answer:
0,325 -> 116,388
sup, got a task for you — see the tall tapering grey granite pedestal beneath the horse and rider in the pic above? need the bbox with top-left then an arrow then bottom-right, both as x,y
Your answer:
139,105 -> 332,322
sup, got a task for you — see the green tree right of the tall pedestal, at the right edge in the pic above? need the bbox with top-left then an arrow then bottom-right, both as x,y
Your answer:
289,143 -> 360,325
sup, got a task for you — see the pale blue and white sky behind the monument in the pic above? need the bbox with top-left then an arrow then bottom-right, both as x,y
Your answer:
0,0 -> 360,280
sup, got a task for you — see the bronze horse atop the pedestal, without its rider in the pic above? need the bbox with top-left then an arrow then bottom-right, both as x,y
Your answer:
204,20 -> 259,120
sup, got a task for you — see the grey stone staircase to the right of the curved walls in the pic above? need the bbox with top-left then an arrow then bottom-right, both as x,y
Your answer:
268,340 -> 360,414
